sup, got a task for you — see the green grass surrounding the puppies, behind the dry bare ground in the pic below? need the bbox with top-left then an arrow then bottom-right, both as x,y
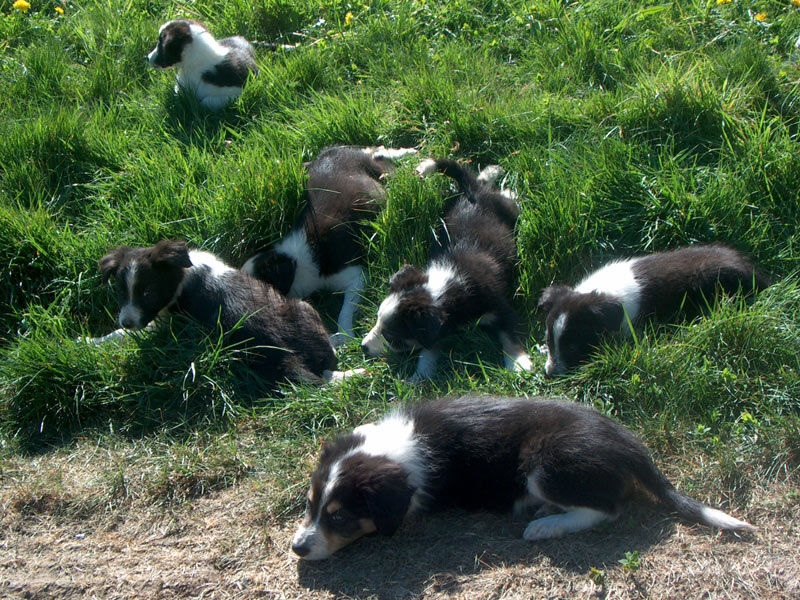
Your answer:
0,0 -> 800,596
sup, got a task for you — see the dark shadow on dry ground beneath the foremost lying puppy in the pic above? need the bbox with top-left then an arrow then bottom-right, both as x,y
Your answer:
297,507 -> 688,599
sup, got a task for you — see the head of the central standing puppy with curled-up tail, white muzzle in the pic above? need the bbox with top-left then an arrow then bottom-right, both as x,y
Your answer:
361,265 -> 444,356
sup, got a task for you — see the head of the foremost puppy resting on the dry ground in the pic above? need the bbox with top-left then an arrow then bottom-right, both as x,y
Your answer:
292,434 -> 414,560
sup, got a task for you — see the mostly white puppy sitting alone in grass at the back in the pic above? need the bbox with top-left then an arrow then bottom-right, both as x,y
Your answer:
147,19 -> 258,109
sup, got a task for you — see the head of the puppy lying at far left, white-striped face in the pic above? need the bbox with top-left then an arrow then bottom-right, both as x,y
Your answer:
99,240 -> 192,329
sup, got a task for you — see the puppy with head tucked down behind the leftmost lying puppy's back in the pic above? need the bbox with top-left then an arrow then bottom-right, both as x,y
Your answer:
242,146 -> 417,346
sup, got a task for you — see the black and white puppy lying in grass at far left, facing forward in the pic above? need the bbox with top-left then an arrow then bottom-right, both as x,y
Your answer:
88,240 -> 352,383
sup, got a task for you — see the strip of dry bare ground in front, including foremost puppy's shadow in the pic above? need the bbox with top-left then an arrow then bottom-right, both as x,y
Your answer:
0,479 -> 800,599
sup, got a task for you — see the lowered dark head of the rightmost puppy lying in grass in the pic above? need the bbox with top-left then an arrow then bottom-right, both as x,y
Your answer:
538,285 -> 624,377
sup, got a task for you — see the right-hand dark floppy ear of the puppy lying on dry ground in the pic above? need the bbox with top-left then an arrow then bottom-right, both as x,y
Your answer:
364,462 -> 414,535
